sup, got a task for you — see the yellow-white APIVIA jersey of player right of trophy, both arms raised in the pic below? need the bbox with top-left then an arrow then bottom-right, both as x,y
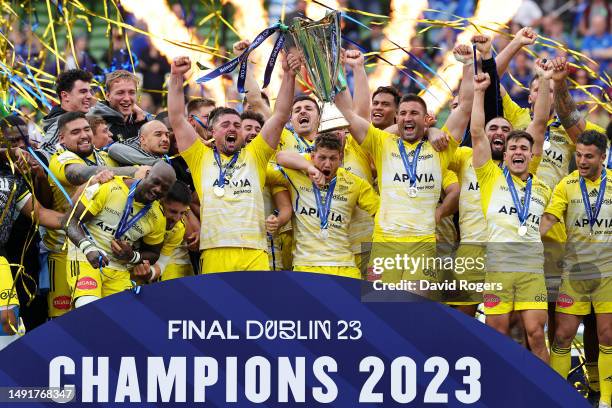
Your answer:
361,124 -> 458,242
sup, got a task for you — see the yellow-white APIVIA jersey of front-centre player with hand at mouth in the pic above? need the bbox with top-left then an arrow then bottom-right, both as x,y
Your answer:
274,168 -> 380,266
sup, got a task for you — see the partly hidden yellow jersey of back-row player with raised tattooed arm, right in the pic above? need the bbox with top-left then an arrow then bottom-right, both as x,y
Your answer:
502,94 -> 605,189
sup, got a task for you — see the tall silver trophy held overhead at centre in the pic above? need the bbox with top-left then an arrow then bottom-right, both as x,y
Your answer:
289,11 -> 349,132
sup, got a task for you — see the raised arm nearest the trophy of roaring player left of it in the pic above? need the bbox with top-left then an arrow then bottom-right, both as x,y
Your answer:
261,54 -> 301,149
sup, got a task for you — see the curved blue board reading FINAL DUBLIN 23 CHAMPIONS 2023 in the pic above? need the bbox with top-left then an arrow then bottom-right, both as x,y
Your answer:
0,272 -> 588,408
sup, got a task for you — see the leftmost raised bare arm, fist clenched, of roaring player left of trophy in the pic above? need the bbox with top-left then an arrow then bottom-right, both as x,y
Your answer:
168,57 -> 198,152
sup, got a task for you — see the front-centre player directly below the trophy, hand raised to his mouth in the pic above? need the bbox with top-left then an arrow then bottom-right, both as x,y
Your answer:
276,133 -> 379,279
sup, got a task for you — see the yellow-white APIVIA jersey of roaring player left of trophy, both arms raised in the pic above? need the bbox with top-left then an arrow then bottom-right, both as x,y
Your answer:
181,135 -> 274,250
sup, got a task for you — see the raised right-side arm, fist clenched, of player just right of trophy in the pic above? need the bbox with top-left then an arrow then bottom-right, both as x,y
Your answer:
446,44 -> 474,143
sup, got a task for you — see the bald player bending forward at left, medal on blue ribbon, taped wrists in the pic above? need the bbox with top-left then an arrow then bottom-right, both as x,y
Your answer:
66,162 -> 176,307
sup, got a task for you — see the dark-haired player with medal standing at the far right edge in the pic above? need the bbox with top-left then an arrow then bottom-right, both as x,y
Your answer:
540,130 -> 612,407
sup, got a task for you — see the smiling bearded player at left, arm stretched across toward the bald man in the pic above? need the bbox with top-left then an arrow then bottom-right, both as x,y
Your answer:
43,112 -> 146,317
